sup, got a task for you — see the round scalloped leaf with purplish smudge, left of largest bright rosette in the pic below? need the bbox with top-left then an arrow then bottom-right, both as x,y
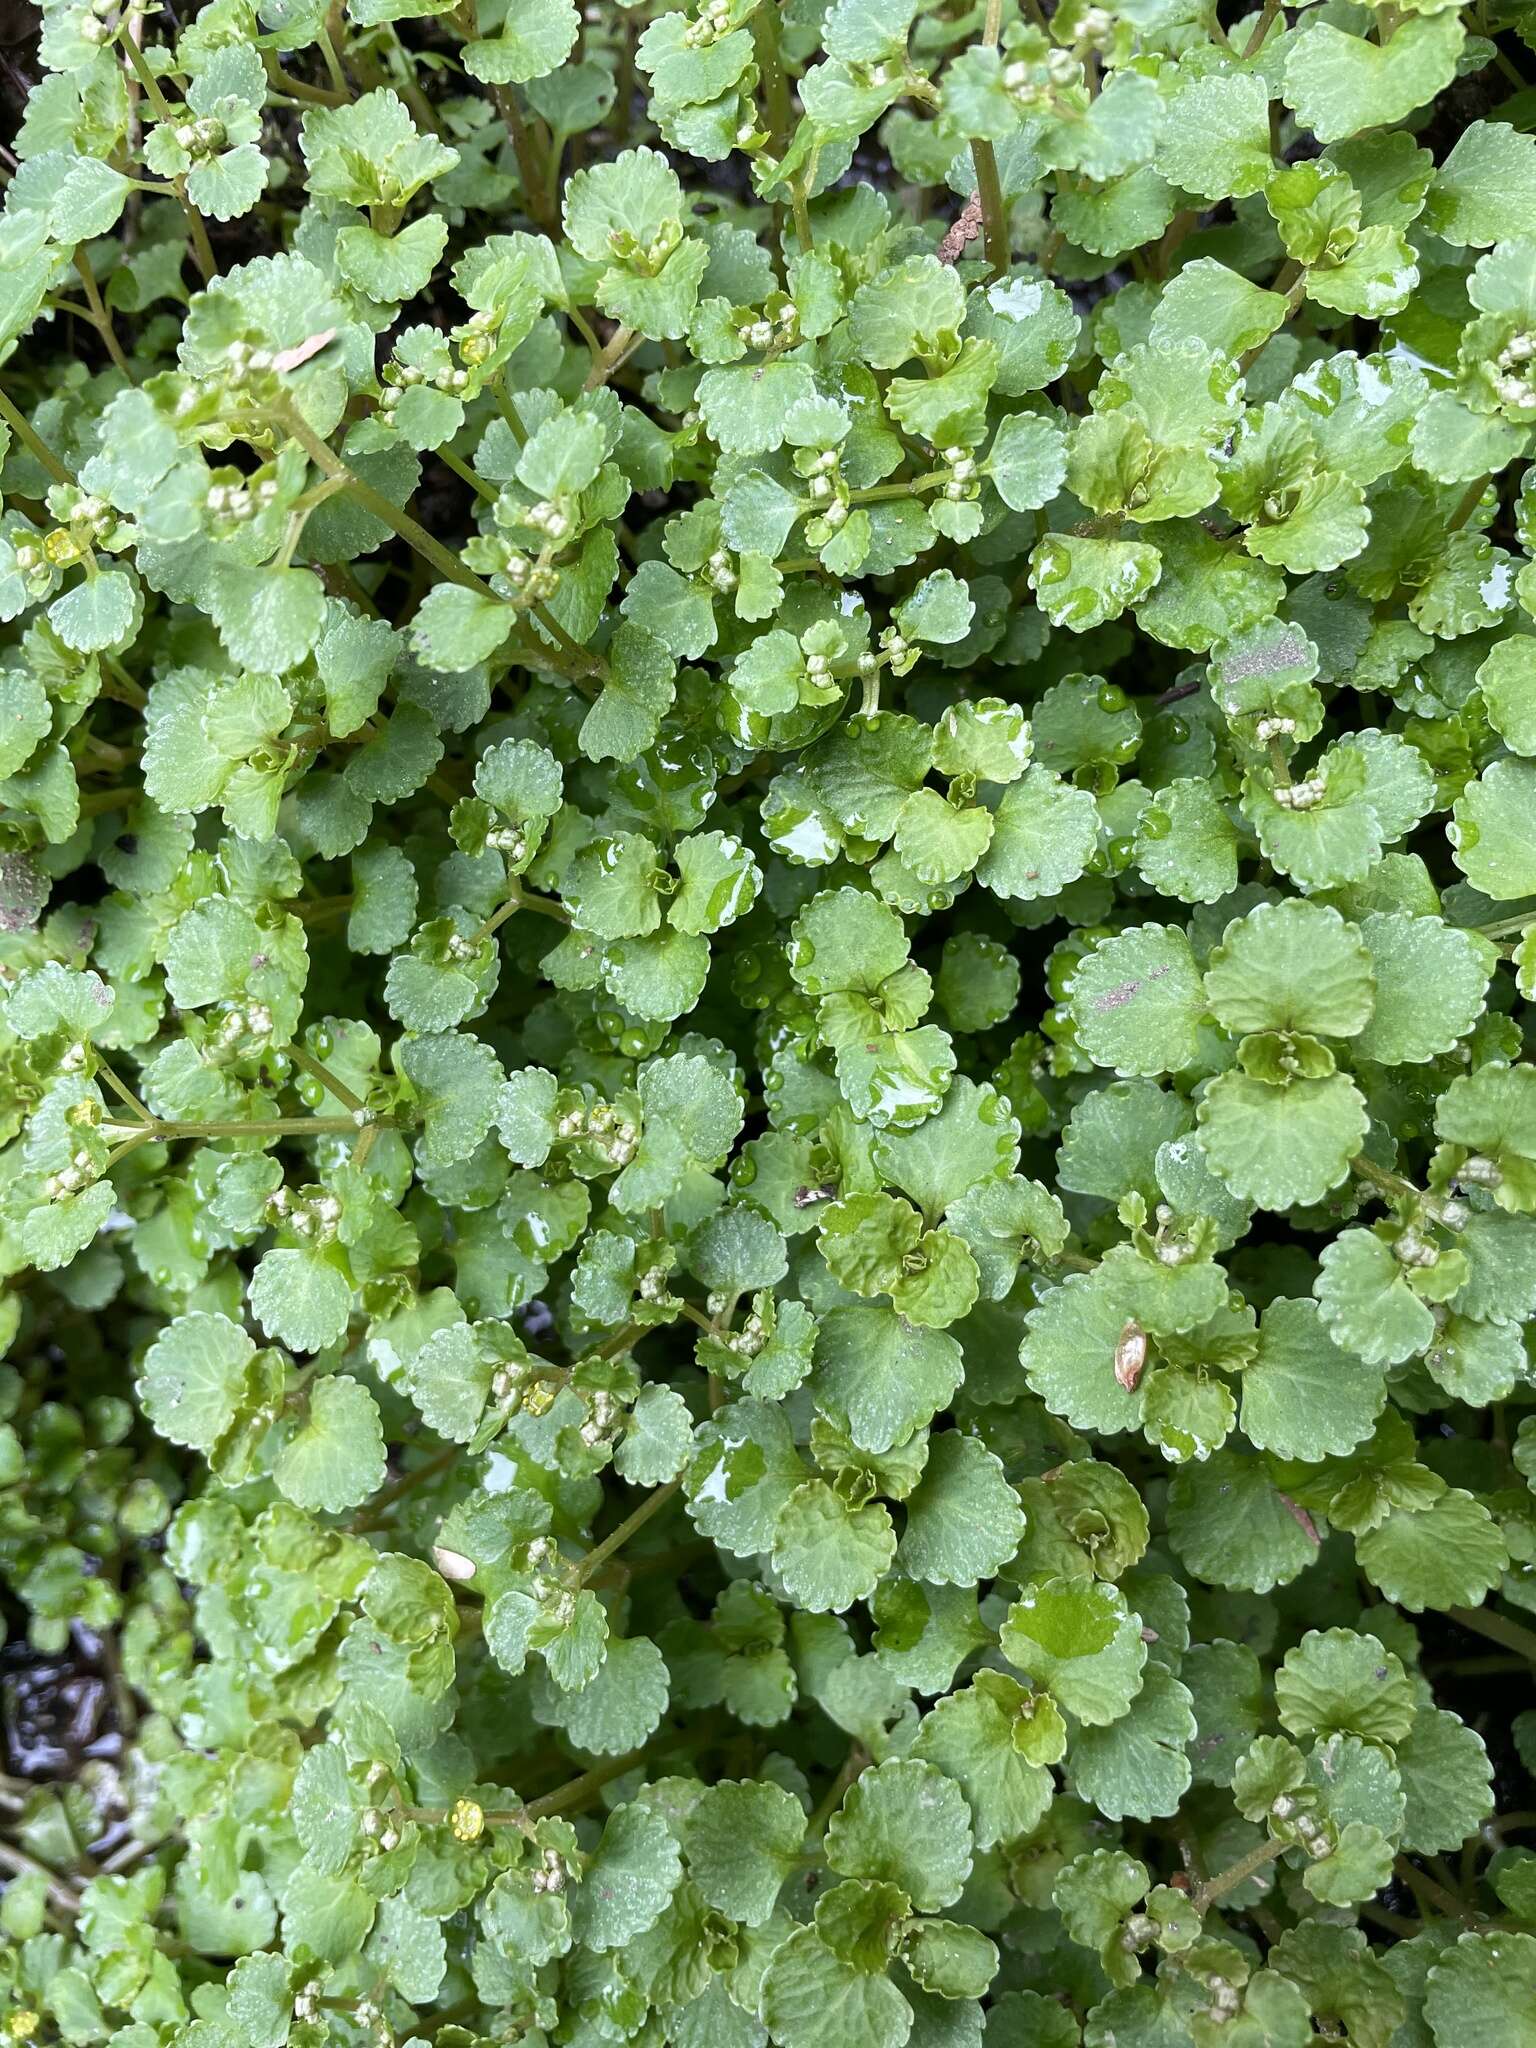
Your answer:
1071,924 -> 1206,1075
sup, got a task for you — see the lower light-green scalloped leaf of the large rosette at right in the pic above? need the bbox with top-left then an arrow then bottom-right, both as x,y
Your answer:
1196,1071 -> 1370,1208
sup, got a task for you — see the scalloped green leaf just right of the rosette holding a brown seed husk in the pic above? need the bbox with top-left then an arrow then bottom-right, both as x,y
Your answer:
1241,1298 -> 1386,1464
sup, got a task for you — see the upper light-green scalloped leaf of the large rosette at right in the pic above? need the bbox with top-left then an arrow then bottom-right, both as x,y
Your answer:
1206,897 -> 1374,1038
